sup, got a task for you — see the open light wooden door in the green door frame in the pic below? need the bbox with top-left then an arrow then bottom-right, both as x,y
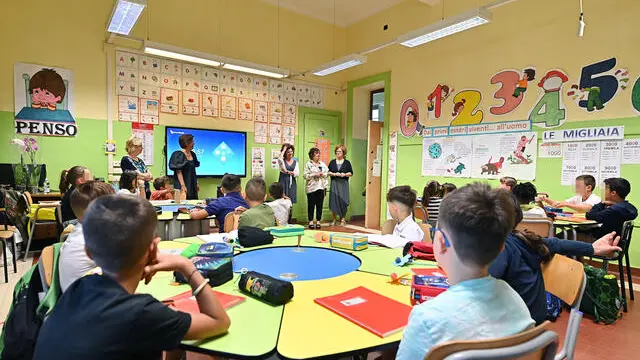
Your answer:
364,121 -> 383,229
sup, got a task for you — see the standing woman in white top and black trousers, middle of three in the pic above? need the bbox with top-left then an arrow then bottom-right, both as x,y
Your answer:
304,148 -> 329,229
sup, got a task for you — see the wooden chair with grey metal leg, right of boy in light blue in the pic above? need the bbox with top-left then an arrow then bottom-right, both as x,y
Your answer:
542,254 -> 587,360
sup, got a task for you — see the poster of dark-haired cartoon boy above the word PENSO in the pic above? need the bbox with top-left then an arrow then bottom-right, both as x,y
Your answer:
13,63 -> 78,136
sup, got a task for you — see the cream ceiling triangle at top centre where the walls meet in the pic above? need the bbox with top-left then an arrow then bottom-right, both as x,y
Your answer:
262,0 -> 440,27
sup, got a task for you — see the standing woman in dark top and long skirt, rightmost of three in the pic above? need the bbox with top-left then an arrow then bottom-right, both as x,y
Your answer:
329,144 -> 353,226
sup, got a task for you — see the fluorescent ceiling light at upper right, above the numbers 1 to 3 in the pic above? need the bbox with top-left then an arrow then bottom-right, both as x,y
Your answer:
397,8 -> 491,47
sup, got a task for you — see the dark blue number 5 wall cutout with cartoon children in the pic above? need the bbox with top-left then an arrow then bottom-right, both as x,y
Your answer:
567,58 -> 629,112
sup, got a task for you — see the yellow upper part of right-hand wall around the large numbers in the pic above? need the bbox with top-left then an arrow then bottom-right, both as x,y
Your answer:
347,0 -> 640,130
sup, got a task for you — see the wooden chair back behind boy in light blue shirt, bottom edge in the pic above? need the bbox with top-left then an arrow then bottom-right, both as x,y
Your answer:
425,321 -> 559,360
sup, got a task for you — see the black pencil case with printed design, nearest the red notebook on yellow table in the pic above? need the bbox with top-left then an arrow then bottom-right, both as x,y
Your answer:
238,271 -> 293,305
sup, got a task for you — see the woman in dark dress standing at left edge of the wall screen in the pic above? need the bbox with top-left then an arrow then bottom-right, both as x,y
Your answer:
169,134 -> 200,200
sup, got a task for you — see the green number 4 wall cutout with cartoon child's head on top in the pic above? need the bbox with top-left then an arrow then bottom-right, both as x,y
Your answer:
529,69 -> 569,128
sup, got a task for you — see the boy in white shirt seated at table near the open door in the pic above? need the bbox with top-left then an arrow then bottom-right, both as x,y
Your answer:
387,185 -> 424,241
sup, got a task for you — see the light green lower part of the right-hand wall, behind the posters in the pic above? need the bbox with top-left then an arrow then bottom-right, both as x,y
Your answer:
397,117 -> 640,267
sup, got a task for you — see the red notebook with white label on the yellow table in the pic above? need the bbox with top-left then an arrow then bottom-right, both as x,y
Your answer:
314,286 -> 411,337
